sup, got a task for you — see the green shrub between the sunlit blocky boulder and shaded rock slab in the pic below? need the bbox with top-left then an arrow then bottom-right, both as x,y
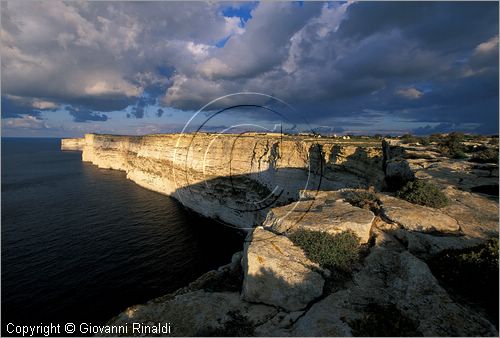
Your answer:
289,229 -> 360,272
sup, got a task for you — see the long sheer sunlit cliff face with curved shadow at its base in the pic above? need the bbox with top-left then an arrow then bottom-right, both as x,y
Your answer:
82,133 -> 383,228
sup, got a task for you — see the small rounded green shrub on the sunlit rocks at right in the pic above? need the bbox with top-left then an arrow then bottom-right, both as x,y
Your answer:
396,180 -> 449,208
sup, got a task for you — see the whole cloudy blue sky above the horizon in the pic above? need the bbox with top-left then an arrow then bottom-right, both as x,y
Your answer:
1,0 -> 499,137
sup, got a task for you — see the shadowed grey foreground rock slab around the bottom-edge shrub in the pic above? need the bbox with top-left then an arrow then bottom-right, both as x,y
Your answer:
288,248 -> 498,336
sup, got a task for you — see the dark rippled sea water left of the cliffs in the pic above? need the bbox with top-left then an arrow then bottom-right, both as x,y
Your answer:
1,138 -> 243,333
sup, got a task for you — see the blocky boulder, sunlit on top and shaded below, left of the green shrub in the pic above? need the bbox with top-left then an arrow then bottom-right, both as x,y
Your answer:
242,227 -> 324,311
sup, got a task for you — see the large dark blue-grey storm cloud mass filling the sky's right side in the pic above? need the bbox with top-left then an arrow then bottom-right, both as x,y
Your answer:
162,2 -> 498,133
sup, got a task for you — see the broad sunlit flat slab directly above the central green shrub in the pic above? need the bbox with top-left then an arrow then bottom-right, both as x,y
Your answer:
264,194 -> 375,243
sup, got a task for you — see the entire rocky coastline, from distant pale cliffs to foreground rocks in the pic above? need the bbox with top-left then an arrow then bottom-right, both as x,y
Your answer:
62,134 -> 498,336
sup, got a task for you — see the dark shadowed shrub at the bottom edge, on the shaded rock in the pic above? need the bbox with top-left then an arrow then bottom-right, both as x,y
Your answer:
349,303 -> 422,337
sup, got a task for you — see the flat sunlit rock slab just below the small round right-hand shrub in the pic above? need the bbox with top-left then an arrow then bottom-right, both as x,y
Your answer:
379,195 -> 460,233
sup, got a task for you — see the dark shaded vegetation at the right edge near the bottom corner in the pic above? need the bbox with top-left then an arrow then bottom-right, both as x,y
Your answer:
427,238 -> 499,329
